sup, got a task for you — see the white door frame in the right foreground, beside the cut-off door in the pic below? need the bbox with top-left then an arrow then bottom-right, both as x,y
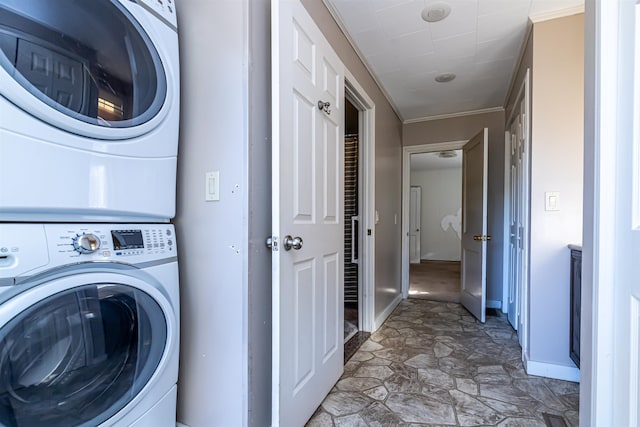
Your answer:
580,0 -> 634,427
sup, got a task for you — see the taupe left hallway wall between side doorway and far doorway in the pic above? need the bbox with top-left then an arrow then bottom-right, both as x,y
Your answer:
302,0 -> 402,317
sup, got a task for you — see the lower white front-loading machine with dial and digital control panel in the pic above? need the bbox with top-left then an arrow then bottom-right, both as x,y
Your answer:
0,223 -> 179,427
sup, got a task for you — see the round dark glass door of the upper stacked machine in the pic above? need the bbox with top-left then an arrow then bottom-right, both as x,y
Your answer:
0,0 -> 167,139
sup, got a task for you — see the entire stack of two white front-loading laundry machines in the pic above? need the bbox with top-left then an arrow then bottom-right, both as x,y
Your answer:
0,0 -> 179,427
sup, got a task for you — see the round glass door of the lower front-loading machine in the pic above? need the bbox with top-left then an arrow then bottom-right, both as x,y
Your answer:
0,283 -> 167,427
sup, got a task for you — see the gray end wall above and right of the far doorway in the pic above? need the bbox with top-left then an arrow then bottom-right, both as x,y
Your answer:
402,111 -> 504,301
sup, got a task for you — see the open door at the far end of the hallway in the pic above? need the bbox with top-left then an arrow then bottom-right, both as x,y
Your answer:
460,128 -> 491,323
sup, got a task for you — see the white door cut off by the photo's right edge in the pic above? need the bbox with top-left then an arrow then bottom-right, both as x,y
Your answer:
608,1 -> 640,427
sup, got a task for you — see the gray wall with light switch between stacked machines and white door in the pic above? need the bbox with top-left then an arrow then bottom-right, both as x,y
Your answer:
176,0 -> 271,427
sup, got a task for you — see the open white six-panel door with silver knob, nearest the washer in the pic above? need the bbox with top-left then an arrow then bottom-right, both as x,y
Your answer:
272,0 -> 344,426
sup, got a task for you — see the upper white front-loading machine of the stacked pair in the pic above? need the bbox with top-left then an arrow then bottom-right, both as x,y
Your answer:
0,0 -> 179,222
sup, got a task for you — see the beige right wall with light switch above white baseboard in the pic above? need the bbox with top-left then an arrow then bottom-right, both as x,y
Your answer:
529,14 -> 584,367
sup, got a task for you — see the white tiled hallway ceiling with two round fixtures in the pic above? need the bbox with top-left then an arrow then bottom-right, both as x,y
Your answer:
325,0 -> 584,121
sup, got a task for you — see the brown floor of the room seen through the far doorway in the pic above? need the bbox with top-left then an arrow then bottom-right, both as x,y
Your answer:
409,260 -> 460,302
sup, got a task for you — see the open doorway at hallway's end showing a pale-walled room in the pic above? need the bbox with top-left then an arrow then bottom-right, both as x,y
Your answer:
409,150 -> 462,302
